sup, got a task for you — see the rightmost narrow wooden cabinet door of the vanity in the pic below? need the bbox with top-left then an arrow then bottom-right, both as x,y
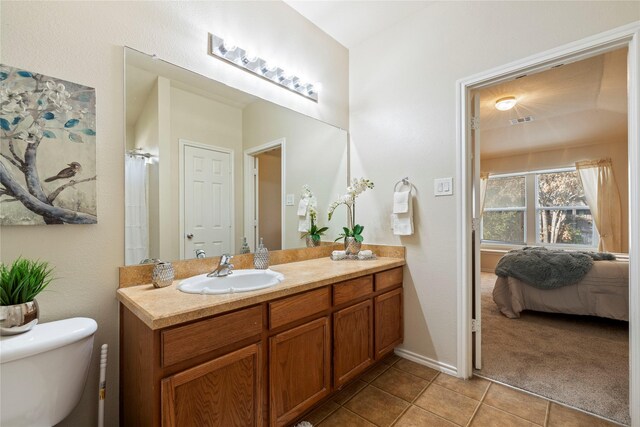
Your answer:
375,288 -> 404,360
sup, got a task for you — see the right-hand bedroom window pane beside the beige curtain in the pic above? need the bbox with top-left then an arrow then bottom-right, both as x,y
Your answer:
536,170 -> 597,246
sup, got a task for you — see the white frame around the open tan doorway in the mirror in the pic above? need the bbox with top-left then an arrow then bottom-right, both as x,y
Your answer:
244,138 -> 287,251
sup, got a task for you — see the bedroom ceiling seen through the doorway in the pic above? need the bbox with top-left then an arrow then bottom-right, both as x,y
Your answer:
479,48 -> 627,158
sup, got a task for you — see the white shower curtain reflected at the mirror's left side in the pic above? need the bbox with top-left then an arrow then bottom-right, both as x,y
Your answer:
124,155 -> 149,265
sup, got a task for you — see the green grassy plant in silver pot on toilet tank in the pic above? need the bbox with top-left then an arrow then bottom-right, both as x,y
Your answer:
0,258 -> 53,335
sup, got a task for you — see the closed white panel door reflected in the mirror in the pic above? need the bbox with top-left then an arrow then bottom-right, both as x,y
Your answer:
183,145 -> 233,259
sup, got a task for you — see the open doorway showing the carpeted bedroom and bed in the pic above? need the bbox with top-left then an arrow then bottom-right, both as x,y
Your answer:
472,48 -> 629,424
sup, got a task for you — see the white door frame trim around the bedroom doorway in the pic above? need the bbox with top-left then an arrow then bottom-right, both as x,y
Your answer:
457,23 -> 640,422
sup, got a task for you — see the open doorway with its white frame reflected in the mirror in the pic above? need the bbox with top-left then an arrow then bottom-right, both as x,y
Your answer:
245,138 -> 285,250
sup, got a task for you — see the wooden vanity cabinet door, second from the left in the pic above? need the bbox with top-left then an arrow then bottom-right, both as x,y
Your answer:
269,317 -> 331,426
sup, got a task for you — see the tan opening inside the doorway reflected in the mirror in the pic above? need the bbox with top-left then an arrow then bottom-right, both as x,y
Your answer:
254,147 -> 282,250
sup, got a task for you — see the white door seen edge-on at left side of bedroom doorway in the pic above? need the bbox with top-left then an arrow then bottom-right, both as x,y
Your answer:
471,93 -> 482,369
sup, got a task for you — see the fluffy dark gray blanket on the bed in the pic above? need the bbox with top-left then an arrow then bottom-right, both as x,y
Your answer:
496,247 -> 616,289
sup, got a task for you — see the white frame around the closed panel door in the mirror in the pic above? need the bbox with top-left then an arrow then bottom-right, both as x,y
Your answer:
178,138 -> 236,259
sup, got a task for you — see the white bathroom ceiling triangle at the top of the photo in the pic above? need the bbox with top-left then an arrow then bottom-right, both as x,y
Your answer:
284,0 -> 430,49
